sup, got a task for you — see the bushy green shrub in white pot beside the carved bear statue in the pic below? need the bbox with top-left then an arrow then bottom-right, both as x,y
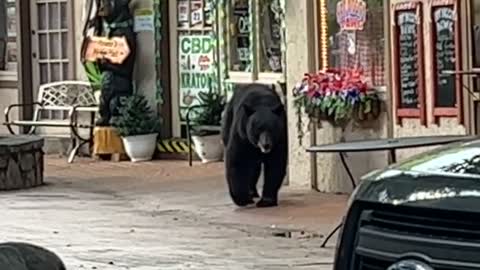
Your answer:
111,94 -> 161,137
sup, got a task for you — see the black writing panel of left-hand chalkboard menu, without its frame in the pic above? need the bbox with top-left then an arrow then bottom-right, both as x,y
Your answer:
396,10 -> 419,108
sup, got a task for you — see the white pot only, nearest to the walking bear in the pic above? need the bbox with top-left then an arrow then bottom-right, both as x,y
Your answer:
192,134 -> 223,163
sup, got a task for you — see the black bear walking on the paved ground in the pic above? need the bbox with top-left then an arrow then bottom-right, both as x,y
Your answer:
222,84 -> 288,207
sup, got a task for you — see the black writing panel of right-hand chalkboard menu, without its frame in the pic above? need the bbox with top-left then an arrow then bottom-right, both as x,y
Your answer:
432,6 -> 457,107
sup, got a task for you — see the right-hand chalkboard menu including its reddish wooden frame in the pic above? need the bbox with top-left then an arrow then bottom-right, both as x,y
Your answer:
430,0 -> 463,122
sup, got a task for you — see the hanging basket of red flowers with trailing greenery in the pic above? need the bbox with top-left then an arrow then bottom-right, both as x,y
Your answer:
293,69 -> 380,144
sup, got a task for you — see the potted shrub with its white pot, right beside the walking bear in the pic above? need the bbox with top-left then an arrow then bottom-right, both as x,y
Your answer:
191,90 -> 226,163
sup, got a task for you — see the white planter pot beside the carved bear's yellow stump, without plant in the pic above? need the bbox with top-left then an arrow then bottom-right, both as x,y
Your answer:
122,133 -> 158,162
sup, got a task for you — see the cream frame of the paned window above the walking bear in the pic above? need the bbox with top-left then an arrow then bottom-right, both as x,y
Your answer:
224,0 -> 286,84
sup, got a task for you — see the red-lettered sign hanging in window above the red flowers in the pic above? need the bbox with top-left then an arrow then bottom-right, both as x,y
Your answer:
337,0 -> 367,31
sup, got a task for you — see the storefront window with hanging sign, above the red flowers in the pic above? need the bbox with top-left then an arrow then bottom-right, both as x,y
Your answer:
327,0 -> 386,86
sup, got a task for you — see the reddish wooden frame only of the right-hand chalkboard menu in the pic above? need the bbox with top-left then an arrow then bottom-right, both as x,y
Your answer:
429,0 -> 463,124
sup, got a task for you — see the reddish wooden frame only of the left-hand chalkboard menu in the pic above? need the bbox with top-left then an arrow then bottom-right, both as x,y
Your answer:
390,0 -> 427,126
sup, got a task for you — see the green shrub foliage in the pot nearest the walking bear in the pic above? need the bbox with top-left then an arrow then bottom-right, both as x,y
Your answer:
193,90 -> 226,126
